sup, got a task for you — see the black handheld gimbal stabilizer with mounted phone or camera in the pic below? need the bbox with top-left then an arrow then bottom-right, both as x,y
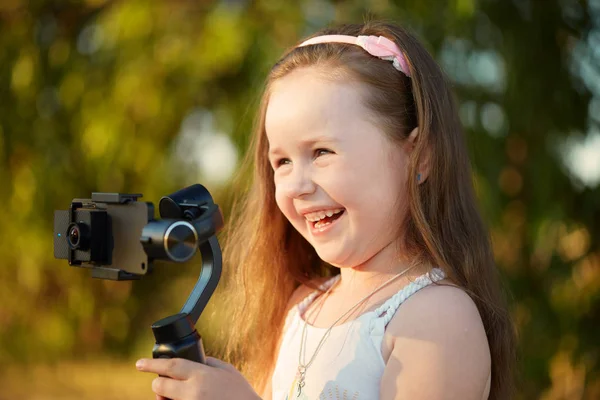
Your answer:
54,184 -> 223,364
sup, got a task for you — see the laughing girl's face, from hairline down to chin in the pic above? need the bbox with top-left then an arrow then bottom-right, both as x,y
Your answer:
265,68 -> 408,267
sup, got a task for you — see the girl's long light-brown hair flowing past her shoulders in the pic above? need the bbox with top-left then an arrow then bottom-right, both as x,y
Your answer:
216,22 -> 515,400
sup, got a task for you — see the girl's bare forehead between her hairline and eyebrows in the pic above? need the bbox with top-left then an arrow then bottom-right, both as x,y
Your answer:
265,67 -> 368,143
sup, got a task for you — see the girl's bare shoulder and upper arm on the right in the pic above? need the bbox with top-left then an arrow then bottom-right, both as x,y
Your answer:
381,281 -> 491,400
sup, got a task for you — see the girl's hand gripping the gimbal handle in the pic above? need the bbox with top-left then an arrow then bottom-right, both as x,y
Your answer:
136,357 -> 260,400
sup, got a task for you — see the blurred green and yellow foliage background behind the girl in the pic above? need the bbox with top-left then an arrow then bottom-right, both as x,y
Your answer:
0,0 -> 600,400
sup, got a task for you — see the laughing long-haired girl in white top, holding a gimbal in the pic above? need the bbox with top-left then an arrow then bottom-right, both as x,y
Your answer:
138,22 -> 514,400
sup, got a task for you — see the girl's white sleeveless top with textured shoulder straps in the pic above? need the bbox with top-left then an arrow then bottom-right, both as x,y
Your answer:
272,268 -> 445,400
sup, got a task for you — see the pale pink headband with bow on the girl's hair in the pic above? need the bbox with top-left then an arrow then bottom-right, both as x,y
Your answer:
298,35 -> 410,77
